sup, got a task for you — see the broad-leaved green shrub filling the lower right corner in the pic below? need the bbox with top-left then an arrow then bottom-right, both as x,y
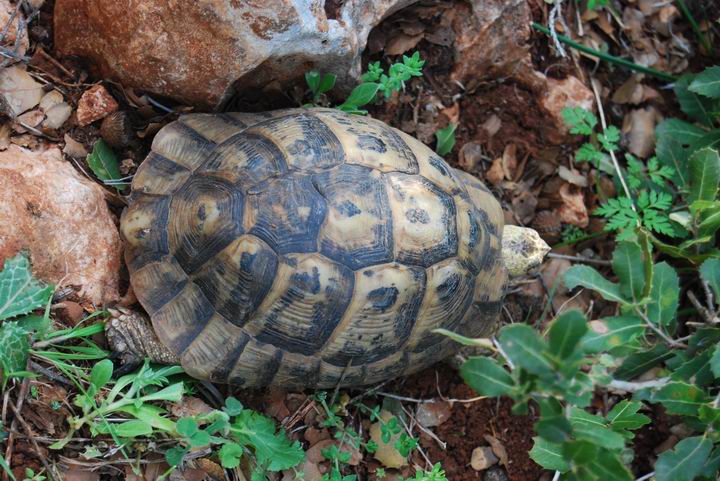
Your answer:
461,238 -> 720,481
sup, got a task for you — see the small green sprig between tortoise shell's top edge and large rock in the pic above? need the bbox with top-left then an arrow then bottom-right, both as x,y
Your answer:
305,52 -> 425,115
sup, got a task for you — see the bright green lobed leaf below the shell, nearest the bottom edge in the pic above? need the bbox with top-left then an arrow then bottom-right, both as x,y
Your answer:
230,410 -> 305,471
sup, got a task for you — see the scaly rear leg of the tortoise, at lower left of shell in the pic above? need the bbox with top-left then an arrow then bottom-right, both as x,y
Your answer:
105,307 -> 180,375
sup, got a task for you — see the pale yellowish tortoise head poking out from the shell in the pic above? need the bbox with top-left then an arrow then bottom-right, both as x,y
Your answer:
502,225 -> 550,277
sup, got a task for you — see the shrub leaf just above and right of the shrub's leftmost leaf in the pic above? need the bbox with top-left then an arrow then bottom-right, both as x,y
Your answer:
499,324 -> 553,375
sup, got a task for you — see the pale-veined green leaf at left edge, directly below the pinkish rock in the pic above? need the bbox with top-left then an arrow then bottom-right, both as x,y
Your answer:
0,253 -> 53,321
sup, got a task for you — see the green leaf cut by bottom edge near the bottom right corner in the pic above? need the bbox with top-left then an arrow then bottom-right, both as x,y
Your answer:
655,436 -> 713,481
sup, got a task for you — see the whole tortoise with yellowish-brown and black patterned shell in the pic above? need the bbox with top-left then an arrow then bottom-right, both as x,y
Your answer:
107,108 -> 549,388
